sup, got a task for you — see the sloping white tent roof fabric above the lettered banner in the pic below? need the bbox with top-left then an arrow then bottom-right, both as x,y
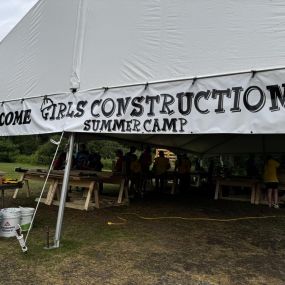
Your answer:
0,0 -> 285,101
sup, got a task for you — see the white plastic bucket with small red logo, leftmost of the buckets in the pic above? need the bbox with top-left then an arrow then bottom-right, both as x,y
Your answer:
0,208 -> 21,237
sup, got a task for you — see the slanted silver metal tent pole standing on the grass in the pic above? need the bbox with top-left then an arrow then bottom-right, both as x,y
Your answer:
53,133 -> 74,248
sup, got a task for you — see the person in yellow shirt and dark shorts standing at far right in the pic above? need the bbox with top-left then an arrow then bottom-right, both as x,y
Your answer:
263,155 -> 280,208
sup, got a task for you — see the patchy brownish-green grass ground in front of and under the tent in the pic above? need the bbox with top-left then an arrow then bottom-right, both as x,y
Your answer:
0,161 -> 285,285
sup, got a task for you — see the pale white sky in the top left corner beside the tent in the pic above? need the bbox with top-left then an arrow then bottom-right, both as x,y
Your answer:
0,0 -> 38,41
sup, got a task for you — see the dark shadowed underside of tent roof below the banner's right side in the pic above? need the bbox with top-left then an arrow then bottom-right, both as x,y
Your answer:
96,134 -> 285,156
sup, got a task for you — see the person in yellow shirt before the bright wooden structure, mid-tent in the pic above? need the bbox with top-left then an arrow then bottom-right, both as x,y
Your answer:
152,150 -> 170,190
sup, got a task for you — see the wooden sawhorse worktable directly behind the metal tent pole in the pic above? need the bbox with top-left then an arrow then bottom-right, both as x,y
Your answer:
21,169 -> 128,210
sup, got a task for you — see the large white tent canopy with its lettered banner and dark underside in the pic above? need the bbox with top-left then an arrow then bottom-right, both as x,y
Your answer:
0,0 -> 285,244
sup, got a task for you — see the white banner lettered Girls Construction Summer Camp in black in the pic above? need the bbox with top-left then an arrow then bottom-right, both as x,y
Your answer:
0,70 -> 285,136
